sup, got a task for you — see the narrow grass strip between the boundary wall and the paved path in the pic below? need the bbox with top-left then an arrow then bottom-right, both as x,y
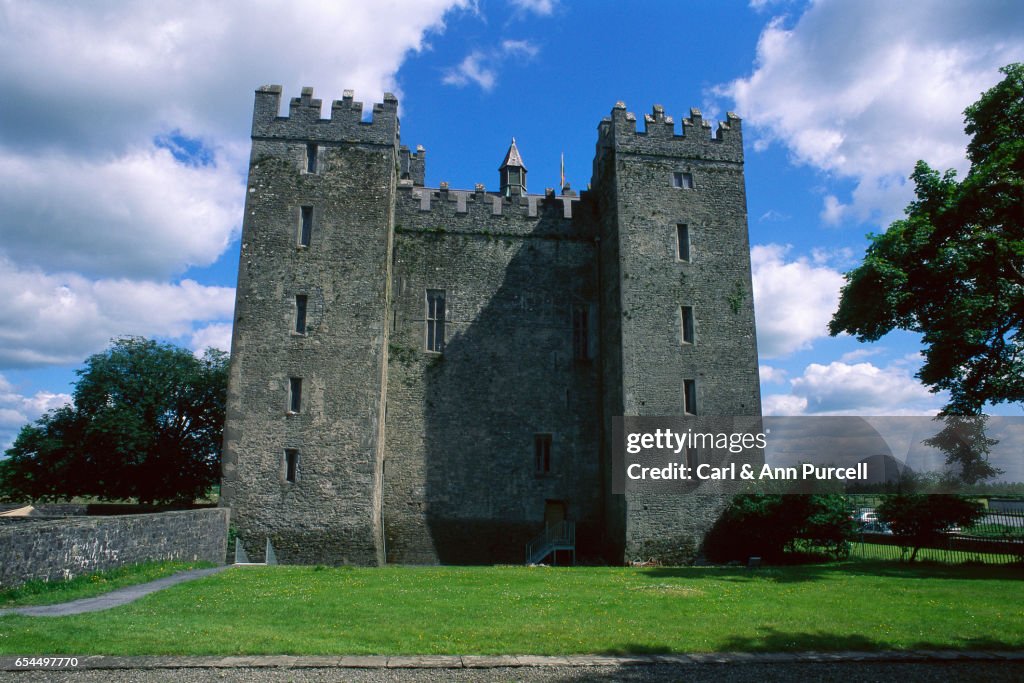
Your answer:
0,562 -> 213,608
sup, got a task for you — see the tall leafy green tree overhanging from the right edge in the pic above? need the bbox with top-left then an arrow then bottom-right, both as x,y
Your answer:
828,63 -> 1024,415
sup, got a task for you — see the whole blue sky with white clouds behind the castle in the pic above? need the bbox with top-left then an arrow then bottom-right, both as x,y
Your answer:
0,0 -> 1024,454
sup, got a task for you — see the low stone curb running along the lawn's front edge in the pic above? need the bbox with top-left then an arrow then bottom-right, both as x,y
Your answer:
0,650 -> 1024,671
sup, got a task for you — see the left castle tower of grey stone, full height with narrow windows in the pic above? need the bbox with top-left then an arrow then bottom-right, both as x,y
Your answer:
222,88 -> 397,564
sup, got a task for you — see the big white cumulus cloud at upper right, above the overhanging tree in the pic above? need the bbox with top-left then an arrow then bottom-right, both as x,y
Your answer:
717,0 -> 1024,224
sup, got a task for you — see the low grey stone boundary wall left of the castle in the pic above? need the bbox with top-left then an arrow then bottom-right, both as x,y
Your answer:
0,508 -> 229,587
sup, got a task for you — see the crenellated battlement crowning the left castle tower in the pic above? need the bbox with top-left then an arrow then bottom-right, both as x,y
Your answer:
252,85 -> 398,144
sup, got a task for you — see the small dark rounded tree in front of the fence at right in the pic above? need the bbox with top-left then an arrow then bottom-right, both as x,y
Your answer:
878,494 -> 985,562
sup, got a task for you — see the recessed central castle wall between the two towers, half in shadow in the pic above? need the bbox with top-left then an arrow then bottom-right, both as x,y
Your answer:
384,187 -> 603,563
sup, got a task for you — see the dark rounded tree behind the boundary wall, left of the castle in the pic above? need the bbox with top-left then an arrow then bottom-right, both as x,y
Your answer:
0,337 -> 227,503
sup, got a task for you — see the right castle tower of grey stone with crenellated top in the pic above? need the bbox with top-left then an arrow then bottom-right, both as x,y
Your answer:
595,104 -> 761,559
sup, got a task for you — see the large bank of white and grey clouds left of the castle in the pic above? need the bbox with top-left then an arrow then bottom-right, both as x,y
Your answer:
0,0 -> 468,374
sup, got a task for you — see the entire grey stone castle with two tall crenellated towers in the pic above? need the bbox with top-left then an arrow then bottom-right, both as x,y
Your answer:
221,86 -> 761,564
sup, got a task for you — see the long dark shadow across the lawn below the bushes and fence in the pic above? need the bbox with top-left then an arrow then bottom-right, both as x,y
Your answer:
642,560 -> 1024,584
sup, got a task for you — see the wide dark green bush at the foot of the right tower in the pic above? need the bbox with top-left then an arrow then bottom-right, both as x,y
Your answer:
703,494 -> 855,562
